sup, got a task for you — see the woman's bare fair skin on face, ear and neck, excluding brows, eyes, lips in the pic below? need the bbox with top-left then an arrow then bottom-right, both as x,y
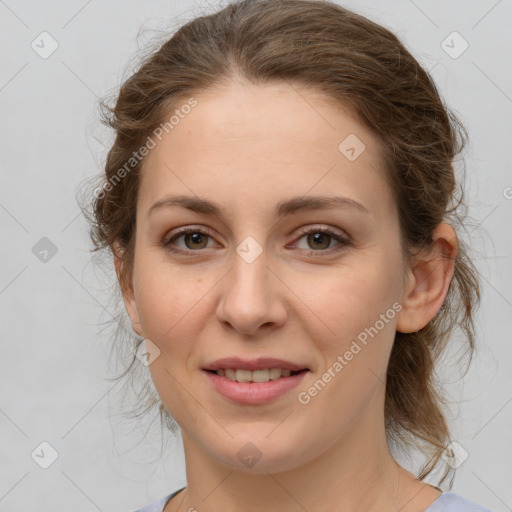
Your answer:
115,81 -> 457,512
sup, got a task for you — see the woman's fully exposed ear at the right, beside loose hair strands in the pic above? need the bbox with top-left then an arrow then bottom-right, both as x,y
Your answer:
396,222 -> 459,333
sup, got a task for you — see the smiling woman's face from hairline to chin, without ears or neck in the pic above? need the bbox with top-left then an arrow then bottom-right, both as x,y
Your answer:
125,83 -> 414,472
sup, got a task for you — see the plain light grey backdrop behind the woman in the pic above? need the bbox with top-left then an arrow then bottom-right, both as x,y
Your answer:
0,0 -> 512,512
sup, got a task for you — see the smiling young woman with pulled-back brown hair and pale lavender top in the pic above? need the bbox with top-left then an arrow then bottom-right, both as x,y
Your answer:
84,0 -> 492,512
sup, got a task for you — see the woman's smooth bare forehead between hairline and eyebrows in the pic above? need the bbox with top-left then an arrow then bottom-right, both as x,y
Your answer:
139,82 -> 393,219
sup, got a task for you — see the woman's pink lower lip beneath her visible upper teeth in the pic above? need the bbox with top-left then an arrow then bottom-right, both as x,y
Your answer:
203,370 -> 309,405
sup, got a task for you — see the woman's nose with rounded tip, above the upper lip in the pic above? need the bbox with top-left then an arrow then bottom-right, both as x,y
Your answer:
217,247 -> 287,336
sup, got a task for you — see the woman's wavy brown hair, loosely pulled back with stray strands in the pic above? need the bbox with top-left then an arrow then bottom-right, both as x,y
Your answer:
79,0 -> 480,486
